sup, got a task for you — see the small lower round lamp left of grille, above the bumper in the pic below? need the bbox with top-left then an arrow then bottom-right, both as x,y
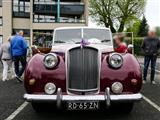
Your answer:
44,83 -> 56,95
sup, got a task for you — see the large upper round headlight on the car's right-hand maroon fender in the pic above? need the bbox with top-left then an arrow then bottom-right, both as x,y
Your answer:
109,53 -> 123,68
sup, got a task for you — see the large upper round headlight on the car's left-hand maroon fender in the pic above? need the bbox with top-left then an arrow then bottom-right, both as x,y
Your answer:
43,54 -> 58,69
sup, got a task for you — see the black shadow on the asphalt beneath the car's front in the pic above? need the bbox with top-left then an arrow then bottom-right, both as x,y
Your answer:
34,104 -> 134,120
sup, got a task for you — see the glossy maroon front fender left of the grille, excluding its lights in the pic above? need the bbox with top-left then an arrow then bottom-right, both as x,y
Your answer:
25,54 -> 66,93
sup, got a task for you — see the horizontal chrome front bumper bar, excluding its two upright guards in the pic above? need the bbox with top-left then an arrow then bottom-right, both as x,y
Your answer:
24,93 -> 142,102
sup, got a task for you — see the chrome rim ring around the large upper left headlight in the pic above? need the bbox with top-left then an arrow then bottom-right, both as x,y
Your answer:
43,53 -> 59,69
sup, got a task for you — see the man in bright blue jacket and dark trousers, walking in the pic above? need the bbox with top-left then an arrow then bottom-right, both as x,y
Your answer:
11,31 -> 28,82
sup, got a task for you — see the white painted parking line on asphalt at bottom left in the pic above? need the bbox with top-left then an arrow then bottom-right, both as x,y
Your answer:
5,102 -> 28,120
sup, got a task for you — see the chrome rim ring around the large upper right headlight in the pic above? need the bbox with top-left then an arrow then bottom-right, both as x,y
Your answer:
108,53 -> 123,69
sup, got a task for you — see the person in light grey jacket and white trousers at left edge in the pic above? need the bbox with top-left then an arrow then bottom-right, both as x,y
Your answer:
0,37 -> 14,81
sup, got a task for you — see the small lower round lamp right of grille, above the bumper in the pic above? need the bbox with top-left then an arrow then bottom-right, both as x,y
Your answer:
112,82 -> 123,94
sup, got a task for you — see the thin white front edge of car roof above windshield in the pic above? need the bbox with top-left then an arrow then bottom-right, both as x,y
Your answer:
55,26 -> 110,31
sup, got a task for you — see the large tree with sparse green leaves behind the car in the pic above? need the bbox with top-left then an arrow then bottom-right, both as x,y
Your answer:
89,0 -> 146,33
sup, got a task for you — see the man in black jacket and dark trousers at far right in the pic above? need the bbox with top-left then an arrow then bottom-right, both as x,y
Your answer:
142,31 -> 160,84
